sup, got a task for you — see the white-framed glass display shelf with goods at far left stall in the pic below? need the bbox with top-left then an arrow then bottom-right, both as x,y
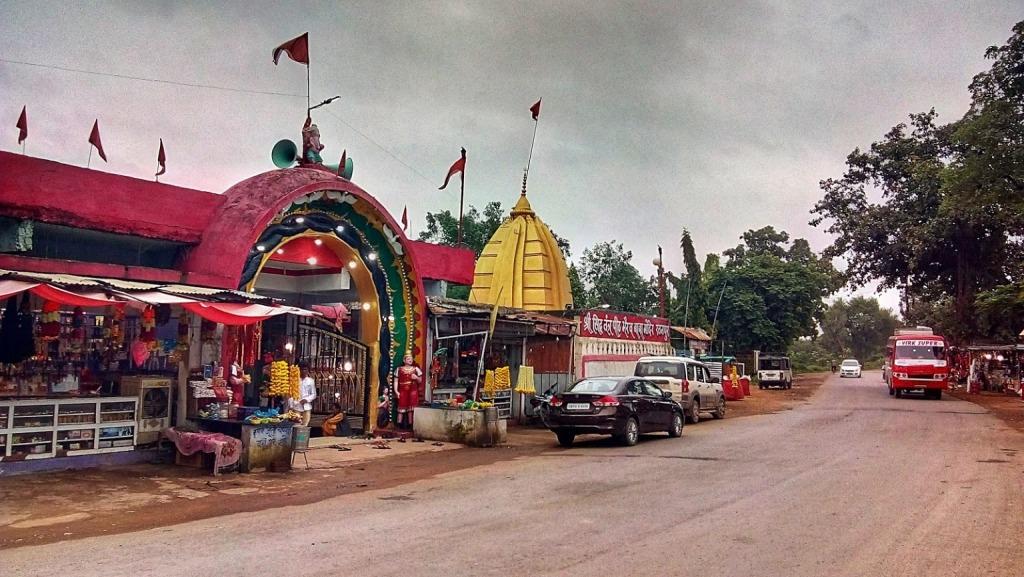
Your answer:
0,397 -> 137,459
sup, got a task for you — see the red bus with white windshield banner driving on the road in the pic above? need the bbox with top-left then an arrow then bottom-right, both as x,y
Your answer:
886,327 -> 949,399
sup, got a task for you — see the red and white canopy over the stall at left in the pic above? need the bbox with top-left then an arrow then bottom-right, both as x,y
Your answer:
0,270 -> 318,325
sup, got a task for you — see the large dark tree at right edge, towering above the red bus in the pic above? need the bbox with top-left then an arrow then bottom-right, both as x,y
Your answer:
811,23 -> 1024,340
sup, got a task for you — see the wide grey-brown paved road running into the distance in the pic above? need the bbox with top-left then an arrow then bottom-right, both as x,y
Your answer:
0,373 -> 1024,577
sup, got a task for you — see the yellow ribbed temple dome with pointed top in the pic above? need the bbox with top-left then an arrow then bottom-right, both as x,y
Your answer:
469,190 -> 572,311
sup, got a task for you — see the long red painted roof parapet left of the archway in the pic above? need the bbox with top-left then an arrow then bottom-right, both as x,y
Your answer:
0,152 -> 224,244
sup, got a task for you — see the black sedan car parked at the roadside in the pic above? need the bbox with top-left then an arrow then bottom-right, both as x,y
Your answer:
541,377 -> 685,447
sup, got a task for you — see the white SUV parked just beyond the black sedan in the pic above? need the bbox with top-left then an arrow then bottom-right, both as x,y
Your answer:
634,357 -> 725,423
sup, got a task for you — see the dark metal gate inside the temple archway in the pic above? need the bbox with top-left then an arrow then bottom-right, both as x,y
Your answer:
295,318 -> 371,430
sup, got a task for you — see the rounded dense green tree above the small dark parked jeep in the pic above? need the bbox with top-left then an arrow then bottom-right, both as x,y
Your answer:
705,226 -> 840,352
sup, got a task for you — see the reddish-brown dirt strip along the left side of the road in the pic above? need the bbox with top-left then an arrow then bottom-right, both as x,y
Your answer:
0,374 -> 826,549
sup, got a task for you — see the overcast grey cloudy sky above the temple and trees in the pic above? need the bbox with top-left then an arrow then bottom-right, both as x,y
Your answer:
0,0 -> 1024,313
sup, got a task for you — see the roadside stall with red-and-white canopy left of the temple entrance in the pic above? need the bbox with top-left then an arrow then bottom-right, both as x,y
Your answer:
0,271 -> 312,468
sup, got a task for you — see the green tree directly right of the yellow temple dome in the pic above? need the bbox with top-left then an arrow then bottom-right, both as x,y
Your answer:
579,242 -> 657,314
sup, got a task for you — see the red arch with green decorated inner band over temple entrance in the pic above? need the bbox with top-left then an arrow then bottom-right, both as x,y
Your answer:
184,167 -> 427,423
